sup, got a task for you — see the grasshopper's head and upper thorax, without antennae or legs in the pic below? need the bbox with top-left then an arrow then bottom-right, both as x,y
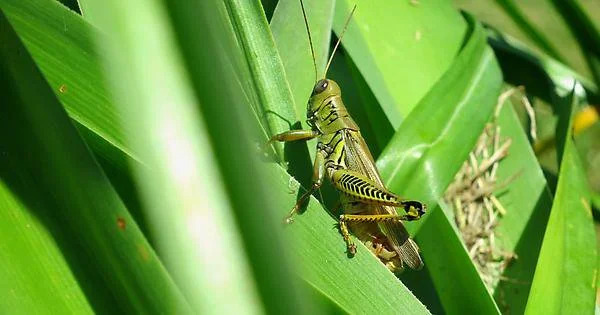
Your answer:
306,79 -> 358,134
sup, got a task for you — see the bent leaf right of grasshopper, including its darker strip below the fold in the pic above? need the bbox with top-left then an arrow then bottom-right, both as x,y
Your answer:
377,17 -> 502,313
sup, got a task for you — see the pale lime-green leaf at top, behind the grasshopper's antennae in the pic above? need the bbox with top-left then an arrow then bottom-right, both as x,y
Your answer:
334,0 -> 467,124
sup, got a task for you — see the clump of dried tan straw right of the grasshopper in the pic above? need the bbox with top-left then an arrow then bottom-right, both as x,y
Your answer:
444,89 -> 535,292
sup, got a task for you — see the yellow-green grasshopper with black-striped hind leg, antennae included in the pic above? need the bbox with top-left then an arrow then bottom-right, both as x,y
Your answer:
269,0 -> 426,272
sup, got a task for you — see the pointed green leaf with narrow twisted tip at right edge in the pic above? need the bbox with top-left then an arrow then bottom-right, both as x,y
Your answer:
525,93 -> 597,314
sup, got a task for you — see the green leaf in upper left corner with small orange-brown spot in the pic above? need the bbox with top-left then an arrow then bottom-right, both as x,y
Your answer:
0,0 -> 152,239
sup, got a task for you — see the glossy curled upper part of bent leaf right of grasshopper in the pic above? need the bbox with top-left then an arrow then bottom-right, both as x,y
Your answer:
377,17 -> 502,223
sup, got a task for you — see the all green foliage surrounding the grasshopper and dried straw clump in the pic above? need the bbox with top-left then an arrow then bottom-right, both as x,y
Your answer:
0,0 -> 600,314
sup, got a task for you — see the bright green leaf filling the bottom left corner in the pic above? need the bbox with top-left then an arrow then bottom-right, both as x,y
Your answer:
0,180 -> 93,314
